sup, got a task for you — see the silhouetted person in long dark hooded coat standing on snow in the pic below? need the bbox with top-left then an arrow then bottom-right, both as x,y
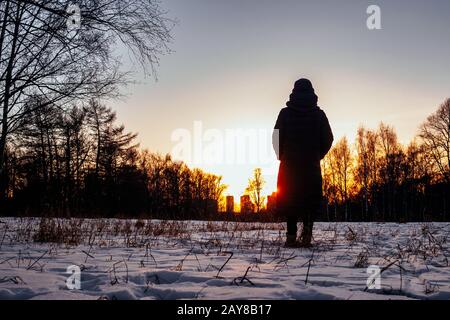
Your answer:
273,79 -> 333,247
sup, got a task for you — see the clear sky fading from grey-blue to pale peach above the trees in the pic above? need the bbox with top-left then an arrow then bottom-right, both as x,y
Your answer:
112,0 -> 450,196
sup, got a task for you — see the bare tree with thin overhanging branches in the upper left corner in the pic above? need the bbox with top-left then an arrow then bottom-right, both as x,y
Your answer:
0,0 -> 172,197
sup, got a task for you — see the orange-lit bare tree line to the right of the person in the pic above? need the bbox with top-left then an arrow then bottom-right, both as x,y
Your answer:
322,99 -> 450,221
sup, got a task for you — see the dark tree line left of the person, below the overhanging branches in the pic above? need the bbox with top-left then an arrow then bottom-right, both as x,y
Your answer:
2,100 -> 225,218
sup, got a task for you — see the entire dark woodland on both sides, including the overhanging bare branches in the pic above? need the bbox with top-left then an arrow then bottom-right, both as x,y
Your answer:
0,0 -> 450,221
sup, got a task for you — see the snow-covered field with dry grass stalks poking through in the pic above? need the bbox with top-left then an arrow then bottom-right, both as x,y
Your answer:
0,218 -> 450,299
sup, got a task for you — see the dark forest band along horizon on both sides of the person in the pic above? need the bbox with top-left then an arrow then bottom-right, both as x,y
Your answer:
1,99 -> 450,222
